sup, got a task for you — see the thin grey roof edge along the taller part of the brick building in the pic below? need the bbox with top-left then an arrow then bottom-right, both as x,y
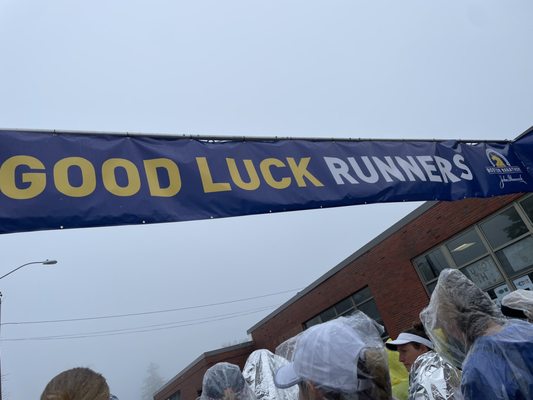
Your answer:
247,201 -> 438,334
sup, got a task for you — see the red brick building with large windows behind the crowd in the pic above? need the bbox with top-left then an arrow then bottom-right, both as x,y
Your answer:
154,194 -> 533,400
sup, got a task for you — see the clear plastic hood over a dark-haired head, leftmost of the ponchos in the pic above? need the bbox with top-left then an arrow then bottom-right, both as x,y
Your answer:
200,362 -> 256,400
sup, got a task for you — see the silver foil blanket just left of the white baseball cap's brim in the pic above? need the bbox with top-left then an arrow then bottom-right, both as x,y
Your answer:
242,349 -> 298,400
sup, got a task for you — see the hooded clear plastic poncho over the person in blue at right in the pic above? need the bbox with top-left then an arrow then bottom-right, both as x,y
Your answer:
420,269 -> 533,400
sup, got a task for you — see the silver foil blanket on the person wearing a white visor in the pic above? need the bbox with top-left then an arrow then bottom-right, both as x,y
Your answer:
409,351 -> 463,400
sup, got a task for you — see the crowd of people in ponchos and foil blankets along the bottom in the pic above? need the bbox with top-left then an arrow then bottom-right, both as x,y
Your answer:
41,269 -> 533,400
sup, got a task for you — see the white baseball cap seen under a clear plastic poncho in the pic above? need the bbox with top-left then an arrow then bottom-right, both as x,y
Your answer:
274,318 -> 368,393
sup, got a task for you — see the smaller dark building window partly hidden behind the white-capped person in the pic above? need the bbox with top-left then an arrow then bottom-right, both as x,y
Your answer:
304,286 -> 388,337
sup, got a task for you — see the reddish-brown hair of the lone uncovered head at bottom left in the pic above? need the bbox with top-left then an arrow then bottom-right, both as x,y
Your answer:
41,368 -> 109,400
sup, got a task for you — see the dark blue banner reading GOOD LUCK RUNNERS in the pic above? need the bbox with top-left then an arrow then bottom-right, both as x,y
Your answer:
0,131 -> 533,233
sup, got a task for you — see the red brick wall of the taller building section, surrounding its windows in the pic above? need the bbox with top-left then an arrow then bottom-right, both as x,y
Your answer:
251,195 -> 521,351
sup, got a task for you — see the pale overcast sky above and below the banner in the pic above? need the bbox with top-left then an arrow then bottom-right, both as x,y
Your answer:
0,0 -> 533,400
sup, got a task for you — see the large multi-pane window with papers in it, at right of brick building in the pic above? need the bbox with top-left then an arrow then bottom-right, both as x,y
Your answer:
413,195 -> 533,303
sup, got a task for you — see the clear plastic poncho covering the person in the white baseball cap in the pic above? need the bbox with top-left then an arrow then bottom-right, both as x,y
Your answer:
275,311 -> 392,400
